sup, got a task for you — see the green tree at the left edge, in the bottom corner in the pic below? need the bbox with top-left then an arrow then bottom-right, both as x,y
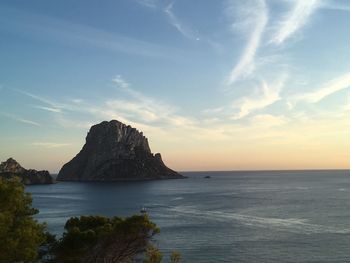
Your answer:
0,177 -> 45,263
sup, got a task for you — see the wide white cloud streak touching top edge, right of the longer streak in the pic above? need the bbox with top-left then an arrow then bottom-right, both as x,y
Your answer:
270,0 -> 321,45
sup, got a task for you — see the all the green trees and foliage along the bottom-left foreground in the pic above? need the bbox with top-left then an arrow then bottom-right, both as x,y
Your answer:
0,177 -> 180,263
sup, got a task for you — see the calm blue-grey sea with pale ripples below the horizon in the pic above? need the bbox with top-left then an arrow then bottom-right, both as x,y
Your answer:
27,171 -> 350,263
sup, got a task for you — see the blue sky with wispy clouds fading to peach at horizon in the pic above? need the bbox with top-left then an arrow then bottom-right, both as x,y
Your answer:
0,0 -> 350,173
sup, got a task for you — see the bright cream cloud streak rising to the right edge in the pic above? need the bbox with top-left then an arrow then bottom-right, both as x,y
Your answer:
288,73 -> 350,105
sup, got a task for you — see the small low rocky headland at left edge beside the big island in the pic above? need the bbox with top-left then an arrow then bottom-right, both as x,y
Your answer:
0,158 -> 54,185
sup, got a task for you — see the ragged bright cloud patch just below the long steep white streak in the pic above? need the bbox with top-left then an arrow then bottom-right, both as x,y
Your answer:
232,75 -> 287,120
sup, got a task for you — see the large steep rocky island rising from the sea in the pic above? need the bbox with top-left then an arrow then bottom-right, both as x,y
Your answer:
57,120 -> 183,181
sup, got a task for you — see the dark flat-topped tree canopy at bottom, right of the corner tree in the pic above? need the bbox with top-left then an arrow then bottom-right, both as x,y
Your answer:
50,215 -> 159,263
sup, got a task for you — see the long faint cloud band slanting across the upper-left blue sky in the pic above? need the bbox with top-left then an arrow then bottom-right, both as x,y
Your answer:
0,7 -> 185,60
